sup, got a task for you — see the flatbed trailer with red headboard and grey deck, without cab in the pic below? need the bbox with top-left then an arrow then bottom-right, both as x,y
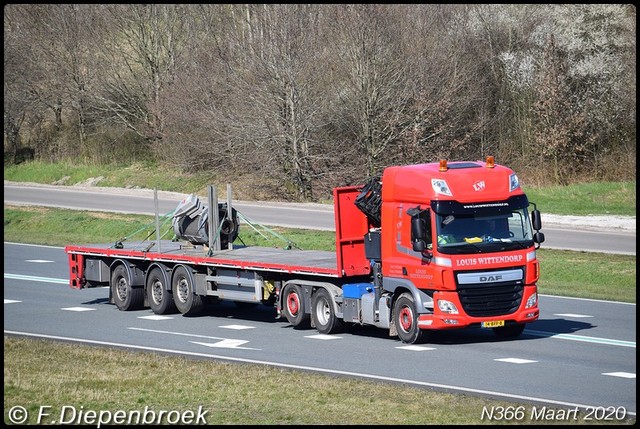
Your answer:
65,186 -> 372,326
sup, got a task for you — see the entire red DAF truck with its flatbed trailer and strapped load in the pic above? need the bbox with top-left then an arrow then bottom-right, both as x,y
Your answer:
65,157 -> 544,344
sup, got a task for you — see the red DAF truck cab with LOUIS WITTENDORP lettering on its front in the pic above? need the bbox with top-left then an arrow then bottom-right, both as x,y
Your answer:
362,157 -> 544,343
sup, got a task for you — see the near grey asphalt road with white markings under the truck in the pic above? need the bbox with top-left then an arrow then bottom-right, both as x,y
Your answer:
4,243 -> 636,423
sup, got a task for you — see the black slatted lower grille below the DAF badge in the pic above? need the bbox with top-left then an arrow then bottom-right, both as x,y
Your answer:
458,284 -> 523,317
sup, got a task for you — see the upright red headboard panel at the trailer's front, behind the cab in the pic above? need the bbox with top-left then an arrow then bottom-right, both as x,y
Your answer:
333,186 -> 371,277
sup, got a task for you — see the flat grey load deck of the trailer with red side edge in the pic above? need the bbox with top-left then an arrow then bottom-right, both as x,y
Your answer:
65,240 -> 340,277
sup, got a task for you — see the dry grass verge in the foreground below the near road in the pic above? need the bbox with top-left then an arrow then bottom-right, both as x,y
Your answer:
4,336 -> 635,427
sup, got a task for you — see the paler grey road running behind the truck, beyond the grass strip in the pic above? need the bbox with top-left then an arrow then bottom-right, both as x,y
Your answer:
4,182 -> 636,255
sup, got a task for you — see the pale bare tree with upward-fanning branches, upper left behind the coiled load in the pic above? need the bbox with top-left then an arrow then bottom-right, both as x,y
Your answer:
91,5 -> 190,157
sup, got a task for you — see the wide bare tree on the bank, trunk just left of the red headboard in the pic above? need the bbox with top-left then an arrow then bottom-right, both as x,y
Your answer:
172,5 -> 326,199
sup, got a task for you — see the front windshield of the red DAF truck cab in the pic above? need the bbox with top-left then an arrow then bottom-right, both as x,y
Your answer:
436,208 -> 533,254
